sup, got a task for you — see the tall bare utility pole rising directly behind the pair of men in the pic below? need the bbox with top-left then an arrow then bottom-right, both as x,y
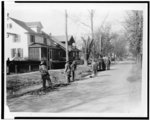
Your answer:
65,10 -> 69,61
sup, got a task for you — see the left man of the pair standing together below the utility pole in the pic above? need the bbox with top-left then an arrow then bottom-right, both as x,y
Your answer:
65,60 -> 71,83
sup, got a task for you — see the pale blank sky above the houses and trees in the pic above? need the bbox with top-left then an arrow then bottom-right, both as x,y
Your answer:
5,2 -> 146,47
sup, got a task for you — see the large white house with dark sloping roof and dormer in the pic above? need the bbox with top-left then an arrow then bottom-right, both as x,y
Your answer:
5,17 -> 58,60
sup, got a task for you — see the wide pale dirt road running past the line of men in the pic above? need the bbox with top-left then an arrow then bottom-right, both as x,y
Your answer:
8,63 -> 141,113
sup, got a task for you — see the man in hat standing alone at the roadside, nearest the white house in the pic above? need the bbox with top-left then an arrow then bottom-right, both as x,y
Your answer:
39,61 -> 52,89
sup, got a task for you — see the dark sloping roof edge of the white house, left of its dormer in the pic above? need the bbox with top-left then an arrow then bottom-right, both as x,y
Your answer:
10,17 -> 35,33
